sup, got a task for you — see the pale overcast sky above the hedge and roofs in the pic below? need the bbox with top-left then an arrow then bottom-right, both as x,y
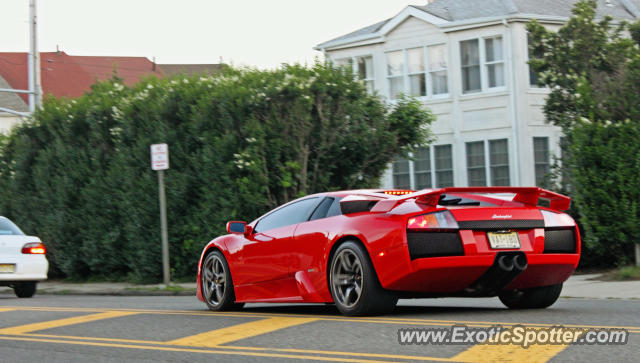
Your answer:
0,0 -> 420,69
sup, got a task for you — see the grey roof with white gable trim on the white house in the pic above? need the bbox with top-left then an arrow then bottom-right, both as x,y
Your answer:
316,0 -> 640,49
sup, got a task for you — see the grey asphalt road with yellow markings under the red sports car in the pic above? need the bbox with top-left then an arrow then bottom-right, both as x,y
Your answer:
0,291 -> 640,362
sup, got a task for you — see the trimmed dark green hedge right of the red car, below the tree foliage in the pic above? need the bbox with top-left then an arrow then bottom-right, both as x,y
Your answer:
571,121 -> 640,266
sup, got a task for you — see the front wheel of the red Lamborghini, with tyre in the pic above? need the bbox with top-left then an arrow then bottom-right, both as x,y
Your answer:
200,251 -> 244,311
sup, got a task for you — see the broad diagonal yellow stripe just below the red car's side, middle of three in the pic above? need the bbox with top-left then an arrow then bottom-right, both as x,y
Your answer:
166,317 -> 318,347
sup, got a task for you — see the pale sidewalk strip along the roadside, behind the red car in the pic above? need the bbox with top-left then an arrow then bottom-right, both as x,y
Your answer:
0,274 -> 640,299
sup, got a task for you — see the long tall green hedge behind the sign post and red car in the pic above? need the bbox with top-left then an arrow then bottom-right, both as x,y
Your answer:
0,63 -> 433,281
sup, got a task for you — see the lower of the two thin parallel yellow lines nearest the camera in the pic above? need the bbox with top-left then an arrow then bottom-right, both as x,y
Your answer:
0,336 -> 402,363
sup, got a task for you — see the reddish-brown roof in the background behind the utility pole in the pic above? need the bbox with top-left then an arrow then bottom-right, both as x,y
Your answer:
0,52 -> 164,102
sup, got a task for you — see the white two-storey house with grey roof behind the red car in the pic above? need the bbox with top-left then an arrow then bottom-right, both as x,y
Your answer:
315,0 -> 640,189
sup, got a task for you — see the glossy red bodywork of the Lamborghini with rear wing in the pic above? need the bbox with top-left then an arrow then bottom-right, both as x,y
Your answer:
197,187 -> 580,302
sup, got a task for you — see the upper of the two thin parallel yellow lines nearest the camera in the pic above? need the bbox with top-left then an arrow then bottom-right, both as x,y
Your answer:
18,334 -> 452,362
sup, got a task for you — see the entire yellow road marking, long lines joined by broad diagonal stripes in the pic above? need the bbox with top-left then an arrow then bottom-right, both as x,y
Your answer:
0,307 -> 640,362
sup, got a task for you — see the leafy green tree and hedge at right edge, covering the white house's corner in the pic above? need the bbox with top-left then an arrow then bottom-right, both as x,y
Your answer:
528,0 -> 640,265
